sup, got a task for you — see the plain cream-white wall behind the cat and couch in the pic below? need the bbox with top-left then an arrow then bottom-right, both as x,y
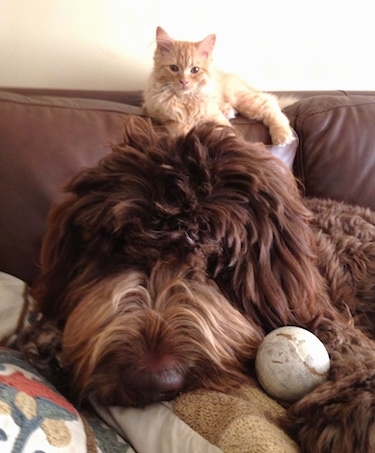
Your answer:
0,0 -> 375,90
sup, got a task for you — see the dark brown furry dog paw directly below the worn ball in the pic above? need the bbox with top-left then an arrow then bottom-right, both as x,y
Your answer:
282,376 -> 375,453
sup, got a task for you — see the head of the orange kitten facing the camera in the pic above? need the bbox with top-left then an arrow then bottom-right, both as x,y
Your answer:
153,27 -> 216,94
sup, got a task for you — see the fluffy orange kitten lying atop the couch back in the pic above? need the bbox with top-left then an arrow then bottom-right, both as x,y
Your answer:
143,27 -> 293,145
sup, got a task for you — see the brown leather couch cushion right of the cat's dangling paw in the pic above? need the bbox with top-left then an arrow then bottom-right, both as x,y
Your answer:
285,95 -> 375,209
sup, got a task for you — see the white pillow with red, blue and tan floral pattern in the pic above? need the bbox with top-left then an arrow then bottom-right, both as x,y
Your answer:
0,350 -> 91,452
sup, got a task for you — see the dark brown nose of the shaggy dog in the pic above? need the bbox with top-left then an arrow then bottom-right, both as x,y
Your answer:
123,367 -> 185,402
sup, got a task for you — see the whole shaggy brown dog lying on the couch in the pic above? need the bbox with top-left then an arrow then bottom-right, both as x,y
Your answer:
19,117 -> 375,453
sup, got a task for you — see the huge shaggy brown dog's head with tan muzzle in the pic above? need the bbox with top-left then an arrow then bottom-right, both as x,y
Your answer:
27,117 -> 326,405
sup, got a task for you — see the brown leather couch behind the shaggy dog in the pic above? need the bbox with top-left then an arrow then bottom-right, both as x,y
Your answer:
0,89 -> 375,451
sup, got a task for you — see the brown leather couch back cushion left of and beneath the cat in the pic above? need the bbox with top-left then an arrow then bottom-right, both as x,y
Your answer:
0,92 -> 297,282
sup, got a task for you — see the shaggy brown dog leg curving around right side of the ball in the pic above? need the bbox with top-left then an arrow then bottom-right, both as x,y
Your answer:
285,320 -> 375,453
